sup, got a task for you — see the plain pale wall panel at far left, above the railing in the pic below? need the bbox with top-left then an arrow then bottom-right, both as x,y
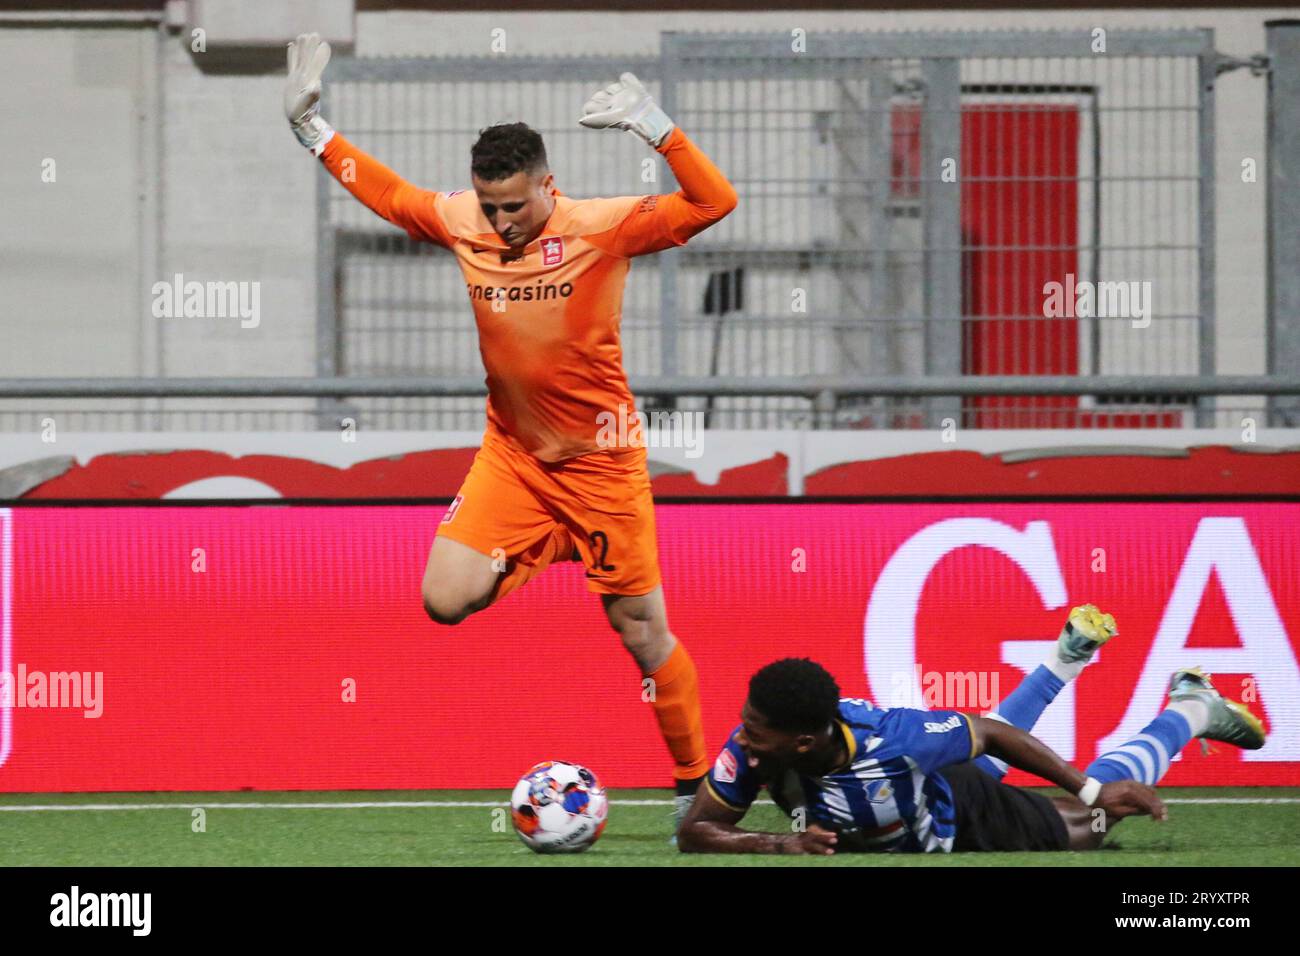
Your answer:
0,29 -> 156,376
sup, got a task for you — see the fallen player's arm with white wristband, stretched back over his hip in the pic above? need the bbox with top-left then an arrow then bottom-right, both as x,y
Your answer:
970,717 -> 1169,819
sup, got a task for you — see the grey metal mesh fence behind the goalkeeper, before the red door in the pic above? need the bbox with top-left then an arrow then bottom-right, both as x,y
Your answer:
0,29 -> 1300,429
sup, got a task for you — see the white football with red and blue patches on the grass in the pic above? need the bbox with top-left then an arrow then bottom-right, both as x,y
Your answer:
510,760 -> 610,853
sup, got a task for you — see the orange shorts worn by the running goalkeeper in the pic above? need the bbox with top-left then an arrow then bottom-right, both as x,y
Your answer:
438,424 -> 660,596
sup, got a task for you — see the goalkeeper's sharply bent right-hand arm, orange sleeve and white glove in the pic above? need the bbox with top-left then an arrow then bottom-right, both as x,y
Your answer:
579,73 -> 738,256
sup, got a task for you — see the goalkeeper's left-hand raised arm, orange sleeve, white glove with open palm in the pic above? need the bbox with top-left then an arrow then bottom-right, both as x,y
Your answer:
285,34 -> 450,246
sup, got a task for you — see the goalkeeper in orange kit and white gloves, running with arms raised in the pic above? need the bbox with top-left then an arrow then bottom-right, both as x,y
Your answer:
285,34 -> 736,822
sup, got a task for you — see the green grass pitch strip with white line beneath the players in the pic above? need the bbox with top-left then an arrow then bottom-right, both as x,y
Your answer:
0,787 -> 1300,866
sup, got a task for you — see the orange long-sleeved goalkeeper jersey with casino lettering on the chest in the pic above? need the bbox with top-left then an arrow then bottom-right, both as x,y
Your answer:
321,129 -> 736,462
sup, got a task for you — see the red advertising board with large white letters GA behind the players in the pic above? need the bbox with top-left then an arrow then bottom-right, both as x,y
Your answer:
0,502 -> 1300,791
